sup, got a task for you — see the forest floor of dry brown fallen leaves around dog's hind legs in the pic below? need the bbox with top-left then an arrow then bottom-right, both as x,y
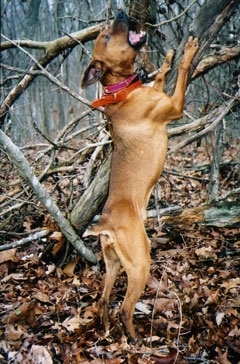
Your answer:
0,140 -> 240,364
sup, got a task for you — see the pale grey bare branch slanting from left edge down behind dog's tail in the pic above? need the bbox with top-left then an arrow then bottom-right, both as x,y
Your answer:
0,130 -> 97,263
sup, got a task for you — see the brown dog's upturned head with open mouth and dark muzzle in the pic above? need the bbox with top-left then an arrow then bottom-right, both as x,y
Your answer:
81,10 -> 147,88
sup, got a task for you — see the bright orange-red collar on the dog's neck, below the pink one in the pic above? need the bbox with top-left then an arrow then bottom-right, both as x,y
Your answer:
92,74 -> 142,109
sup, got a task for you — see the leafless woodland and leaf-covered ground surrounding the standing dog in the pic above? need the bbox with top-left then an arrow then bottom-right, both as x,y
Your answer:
0,0 -> 240,364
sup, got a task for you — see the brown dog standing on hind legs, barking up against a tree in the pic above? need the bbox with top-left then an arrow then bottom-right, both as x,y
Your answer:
82,11 -> 198,338
